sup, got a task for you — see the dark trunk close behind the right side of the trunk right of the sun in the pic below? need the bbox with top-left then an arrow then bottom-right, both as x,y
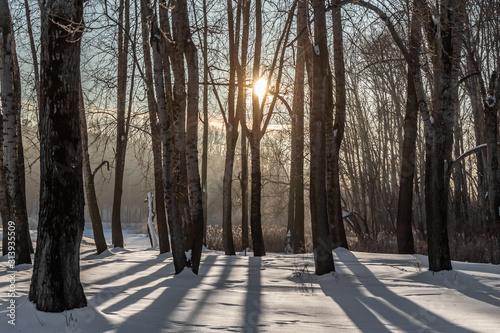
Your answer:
326,1 -> 349,249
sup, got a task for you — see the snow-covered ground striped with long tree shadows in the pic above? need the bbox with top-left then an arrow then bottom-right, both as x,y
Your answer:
0,228 -> 500,333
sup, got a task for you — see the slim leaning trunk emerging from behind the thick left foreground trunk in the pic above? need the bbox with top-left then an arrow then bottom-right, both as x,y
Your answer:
78,81 -> 108,254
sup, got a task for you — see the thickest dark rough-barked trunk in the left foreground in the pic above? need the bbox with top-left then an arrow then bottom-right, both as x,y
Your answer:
29,0 -> 87,312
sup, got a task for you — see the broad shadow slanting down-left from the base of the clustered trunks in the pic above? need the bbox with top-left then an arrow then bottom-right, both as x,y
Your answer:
116,255 -> 217,333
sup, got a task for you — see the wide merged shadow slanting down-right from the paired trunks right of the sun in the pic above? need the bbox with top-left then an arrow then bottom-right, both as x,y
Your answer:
319,251 -> 472,333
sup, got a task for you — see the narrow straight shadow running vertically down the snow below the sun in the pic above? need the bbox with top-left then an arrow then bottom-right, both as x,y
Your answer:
244,257 -> 262,333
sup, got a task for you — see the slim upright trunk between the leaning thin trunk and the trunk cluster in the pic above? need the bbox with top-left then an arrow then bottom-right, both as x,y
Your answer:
111,0 -> 130,247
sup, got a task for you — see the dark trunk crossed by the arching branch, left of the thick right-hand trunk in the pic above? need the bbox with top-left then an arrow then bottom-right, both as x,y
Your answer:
397,1 -> 422,254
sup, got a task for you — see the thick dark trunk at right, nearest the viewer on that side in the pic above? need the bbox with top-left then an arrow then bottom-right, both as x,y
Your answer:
425,0 -> 465,272
